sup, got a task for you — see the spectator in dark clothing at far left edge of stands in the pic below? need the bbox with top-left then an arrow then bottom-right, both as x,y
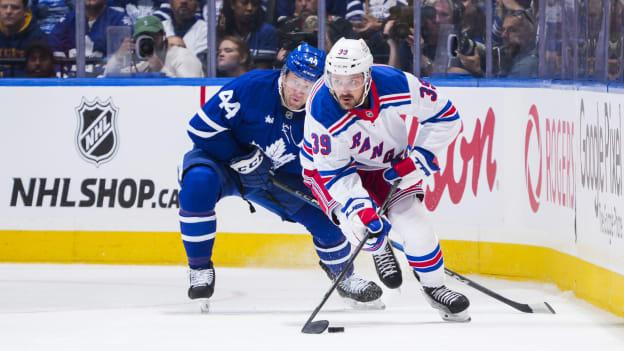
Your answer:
0,0 -> 47,77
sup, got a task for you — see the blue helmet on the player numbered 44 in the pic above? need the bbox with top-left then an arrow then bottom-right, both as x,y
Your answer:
284,43 -> 325,82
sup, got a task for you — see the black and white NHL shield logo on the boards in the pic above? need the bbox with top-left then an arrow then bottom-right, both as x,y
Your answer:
76,97 -> 119,167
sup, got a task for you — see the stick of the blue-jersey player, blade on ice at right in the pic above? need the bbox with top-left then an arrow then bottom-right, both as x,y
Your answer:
271,177 -> 555,314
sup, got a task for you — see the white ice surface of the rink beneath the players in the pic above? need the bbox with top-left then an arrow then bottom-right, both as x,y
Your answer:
0,261 -> 624,351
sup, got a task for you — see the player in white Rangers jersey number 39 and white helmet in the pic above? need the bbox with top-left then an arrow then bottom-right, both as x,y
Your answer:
300,39 -> 470,322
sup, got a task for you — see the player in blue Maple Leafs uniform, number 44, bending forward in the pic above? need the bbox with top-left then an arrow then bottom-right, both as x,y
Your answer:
179,43 -> 396,307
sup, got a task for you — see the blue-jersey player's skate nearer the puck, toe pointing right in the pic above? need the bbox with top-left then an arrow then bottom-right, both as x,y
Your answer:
319,261 -> 386,309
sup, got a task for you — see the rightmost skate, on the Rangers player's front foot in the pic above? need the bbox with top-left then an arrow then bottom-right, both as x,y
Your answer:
423,285 -> 470,322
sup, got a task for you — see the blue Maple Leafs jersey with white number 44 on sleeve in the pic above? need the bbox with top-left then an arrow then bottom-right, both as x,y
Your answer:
187,70 -> 305,175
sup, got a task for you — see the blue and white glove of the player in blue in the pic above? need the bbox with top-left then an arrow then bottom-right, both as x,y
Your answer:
230,149 -> 273,189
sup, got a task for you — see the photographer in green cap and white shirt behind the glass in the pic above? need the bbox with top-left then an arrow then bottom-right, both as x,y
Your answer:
106,16 -> 204,77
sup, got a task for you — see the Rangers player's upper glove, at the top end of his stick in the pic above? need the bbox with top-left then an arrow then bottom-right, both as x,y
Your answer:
384,147 -> 440,189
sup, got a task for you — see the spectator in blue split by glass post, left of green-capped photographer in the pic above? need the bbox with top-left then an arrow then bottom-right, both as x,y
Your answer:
49,0 -> 130,77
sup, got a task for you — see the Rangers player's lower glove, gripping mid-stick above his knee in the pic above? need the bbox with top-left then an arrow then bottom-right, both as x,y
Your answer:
341,198 -> 392,253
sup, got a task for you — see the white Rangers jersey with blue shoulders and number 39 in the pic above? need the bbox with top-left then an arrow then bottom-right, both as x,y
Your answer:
300,65 -> 461,215
